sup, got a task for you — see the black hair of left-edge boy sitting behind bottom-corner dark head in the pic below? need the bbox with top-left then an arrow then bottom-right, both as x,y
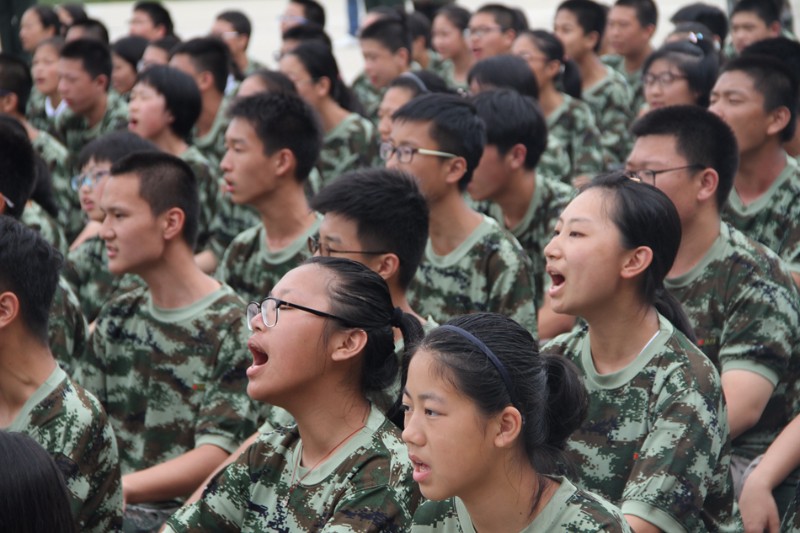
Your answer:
0,216 -> 64,342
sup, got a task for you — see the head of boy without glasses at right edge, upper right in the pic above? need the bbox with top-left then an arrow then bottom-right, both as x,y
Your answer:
709,54 -> 798,151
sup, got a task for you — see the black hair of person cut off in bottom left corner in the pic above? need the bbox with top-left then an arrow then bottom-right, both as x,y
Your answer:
0,430 -> 78,533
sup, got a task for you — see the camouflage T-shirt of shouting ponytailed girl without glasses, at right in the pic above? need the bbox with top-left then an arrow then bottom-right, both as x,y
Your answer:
542,317 -> 743,531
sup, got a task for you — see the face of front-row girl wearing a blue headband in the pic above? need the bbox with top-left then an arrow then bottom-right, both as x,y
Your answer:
403,350 -> 492,500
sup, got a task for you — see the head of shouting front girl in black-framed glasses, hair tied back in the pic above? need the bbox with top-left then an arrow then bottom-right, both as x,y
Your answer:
247,257 -> 422,406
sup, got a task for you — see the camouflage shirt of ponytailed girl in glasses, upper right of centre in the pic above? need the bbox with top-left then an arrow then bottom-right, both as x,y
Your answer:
536,94 -> 605,184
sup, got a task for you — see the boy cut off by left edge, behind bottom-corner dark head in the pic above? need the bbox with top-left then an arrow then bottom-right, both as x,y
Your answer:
0,216 -> 122,532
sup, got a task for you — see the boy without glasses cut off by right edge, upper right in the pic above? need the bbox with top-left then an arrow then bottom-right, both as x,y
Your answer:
709,55 -> 800,283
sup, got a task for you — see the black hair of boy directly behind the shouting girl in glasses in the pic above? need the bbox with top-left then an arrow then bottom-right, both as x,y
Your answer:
311,168 -> 428,289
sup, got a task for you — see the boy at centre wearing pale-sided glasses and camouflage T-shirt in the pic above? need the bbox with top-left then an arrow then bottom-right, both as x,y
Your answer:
388,94 -> 536,334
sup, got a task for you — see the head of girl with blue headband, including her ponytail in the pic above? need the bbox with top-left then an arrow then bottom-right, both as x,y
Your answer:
403,313 -> 588,504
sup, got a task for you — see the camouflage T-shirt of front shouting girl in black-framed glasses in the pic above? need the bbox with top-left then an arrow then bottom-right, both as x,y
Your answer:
165,407 -> 420,533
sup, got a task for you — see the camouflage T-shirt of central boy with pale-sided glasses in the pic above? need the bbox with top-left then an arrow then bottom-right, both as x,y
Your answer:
408,216 -> 537,337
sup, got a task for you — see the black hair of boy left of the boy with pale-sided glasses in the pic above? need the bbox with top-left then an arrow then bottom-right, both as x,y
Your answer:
229,93 -> 322,182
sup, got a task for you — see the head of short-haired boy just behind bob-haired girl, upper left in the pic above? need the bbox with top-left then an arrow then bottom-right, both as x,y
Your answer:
169,37 -> 231,94
